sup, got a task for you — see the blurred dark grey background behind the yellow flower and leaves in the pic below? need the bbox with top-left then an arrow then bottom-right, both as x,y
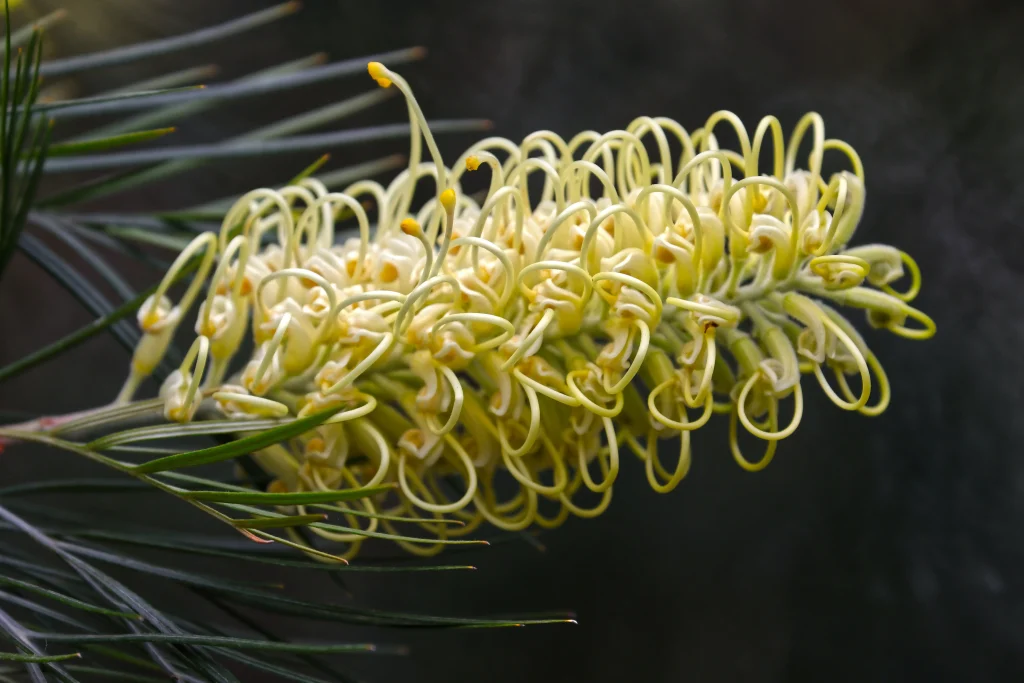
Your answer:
0,0 -> 1024,683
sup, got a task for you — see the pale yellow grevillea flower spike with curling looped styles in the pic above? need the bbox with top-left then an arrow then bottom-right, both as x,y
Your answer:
121,62 -> 935,553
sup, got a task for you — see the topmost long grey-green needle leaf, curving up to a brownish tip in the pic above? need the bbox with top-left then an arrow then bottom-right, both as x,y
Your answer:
43,2 -> 299,76
